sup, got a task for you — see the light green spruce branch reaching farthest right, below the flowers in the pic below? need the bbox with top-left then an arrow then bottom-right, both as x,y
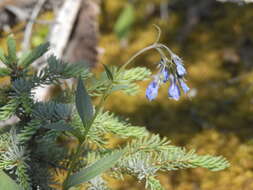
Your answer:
114,135 -> 229,190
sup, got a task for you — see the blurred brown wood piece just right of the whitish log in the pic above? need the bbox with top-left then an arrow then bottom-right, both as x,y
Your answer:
65,0 -> 99,67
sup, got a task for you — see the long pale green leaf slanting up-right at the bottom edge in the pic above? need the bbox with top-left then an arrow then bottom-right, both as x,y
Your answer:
65,151 -> 123,189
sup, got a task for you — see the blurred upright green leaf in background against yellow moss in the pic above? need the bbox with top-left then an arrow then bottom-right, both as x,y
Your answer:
114,4 -> 134,39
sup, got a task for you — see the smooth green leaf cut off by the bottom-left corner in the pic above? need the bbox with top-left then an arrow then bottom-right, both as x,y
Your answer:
0,170 -> 22,190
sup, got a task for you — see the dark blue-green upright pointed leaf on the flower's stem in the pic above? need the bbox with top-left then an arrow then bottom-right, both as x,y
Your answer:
76,77 -> 93,126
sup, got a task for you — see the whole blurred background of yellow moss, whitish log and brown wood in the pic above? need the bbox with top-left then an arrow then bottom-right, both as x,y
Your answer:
0,0 -> 253,190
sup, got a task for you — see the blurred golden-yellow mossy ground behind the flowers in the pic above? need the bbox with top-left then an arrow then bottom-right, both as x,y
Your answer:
100,0 -> 253,190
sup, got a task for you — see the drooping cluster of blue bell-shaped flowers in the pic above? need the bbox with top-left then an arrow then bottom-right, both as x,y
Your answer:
146,54 -> 190,101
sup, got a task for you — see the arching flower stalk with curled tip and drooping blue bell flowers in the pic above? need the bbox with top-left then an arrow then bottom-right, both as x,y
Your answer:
120,25 -> 190,101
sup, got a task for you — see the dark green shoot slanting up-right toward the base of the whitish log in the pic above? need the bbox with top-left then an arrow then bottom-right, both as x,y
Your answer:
18,42 -> 50,67
